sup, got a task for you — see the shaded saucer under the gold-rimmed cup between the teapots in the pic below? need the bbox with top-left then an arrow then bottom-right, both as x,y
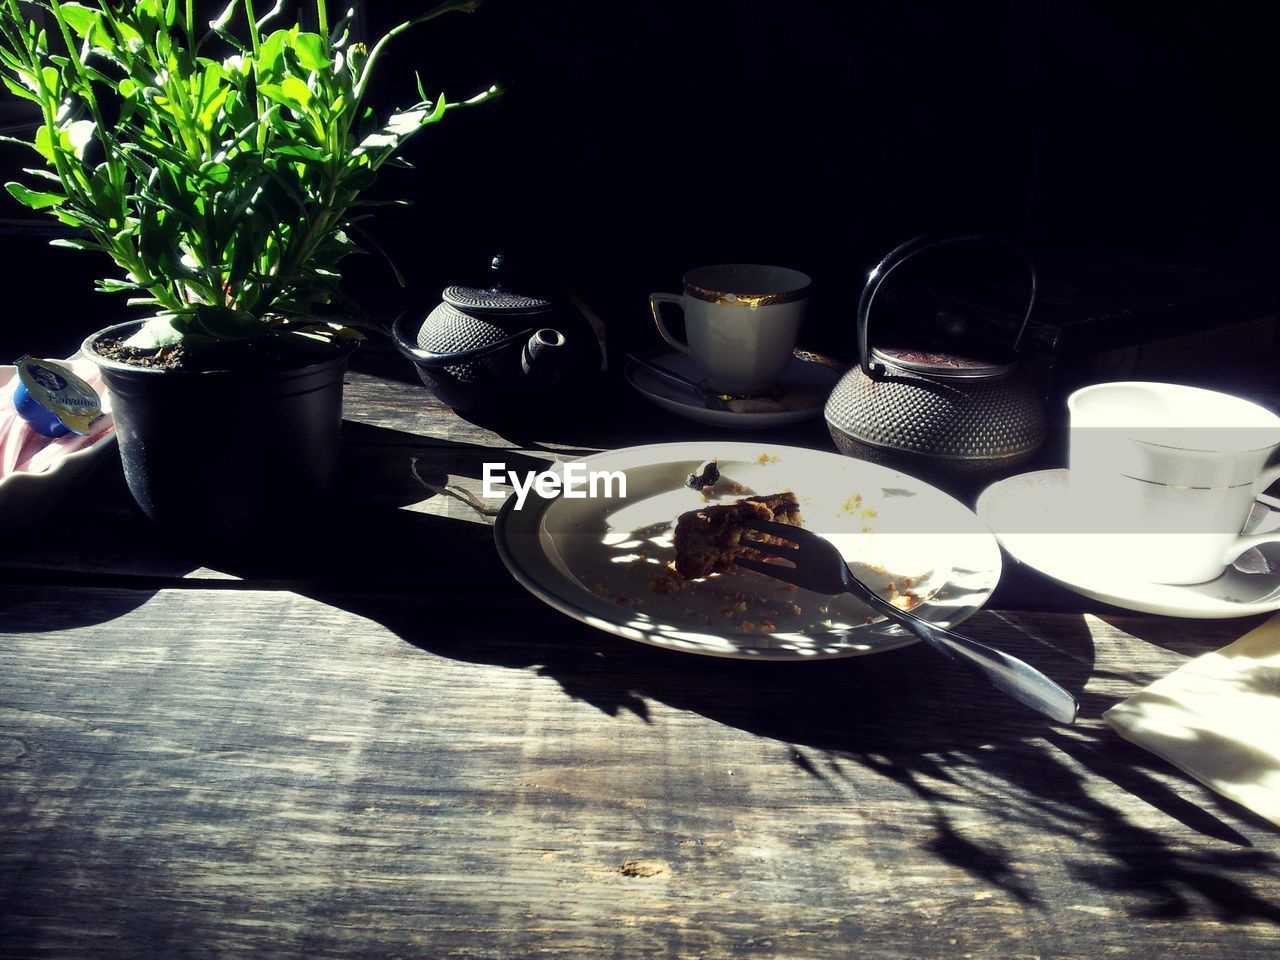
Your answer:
625,349 -> 844,430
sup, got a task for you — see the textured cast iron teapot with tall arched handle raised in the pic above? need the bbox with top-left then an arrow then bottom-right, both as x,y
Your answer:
824,236 -> 1046,492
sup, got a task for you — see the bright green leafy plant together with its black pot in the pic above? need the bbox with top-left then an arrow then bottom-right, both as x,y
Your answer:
0,0 -> 497,540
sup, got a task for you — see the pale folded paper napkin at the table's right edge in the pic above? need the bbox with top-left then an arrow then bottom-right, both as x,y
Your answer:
1102,614 -> 1280,826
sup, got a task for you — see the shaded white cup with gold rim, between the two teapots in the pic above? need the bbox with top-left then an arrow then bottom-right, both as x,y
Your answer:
649,264 -> 809,394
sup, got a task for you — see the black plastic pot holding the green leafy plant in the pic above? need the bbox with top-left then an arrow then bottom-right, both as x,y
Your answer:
83,323 -> 351,547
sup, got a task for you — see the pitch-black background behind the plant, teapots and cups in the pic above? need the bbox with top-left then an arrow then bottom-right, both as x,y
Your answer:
0,0 -> 1280,368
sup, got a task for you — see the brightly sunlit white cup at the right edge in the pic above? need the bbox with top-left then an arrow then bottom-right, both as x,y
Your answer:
1068,381 -> 1280,584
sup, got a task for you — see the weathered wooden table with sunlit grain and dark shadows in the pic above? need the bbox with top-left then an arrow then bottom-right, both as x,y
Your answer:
0,351 -> 1280,960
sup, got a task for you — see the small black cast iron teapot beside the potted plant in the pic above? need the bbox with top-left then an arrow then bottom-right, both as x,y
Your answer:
392,252 -> 604,412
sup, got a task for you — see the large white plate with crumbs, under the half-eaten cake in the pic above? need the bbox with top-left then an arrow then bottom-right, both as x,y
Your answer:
494,442 -> 1000,660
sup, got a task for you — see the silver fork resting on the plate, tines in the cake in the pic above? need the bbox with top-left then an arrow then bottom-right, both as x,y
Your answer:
735,520 -> 1079,723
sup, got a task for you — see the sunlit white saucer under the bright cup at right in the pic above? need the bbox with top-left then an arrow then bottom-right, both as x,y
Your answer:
978,470 -> 1280,620
